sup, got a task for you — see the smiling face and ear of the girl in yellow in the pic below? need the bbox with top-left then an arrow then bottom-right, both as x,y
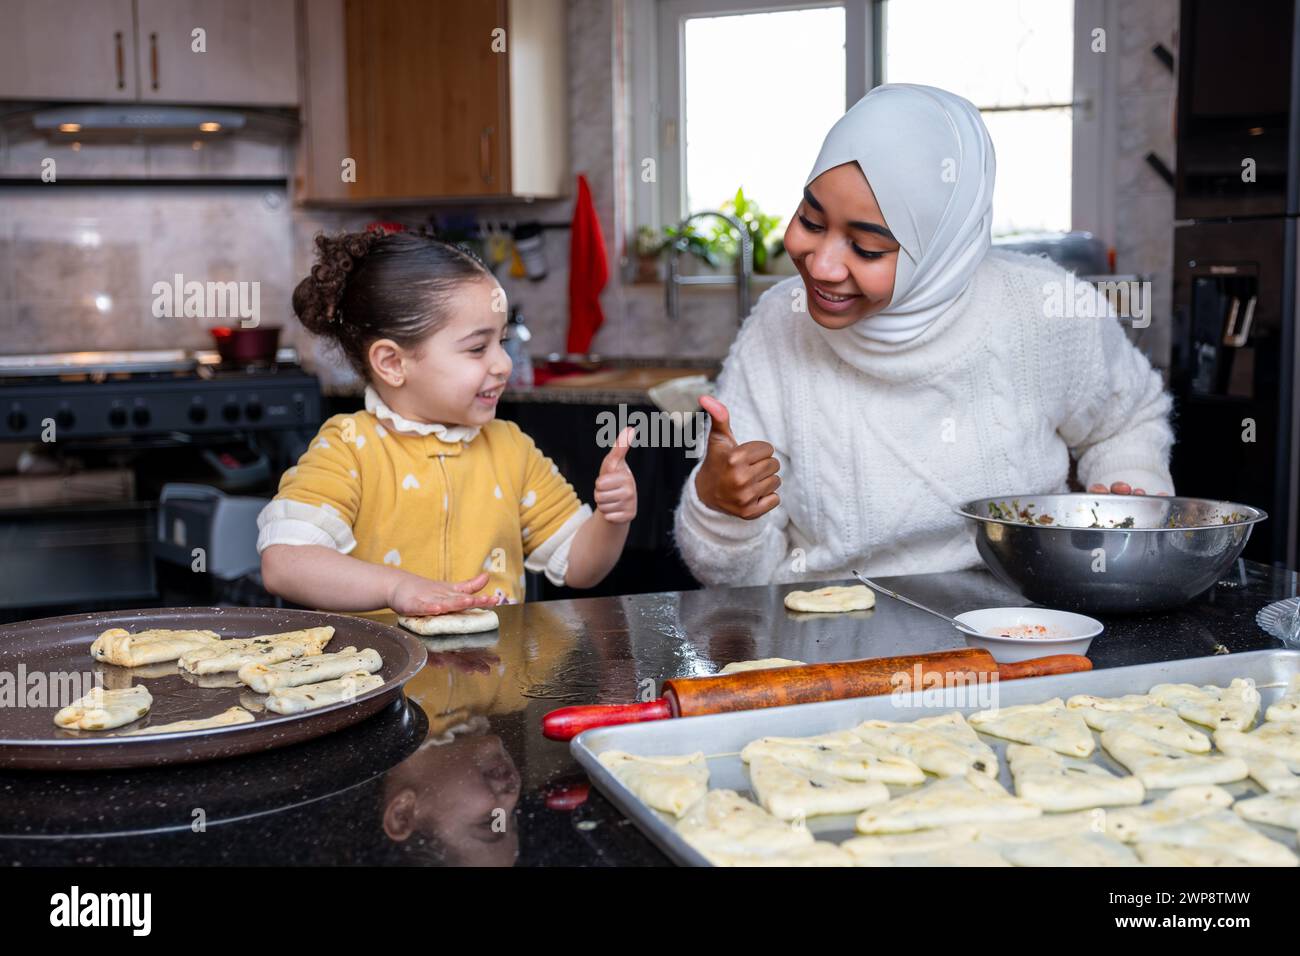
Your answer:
369,276 -> 512,427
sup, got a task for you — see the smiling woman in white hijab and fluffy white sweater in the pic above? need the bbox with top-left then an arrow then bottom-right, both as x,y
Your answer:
676,85 -> 1173,585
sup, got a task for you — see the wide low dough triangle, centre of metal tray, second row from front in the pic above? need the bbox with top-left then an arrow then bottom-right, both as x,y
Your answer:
857,770 -> 1043,834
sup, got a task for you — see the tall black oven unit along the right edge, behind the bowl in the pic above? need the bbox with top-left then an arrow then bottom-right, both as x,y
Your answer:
1170,0 -> 1300,567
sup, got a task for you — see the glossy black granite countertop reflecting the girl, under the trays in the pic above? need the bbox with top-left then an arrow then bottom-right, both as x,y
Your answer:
0,561 -> 1296,866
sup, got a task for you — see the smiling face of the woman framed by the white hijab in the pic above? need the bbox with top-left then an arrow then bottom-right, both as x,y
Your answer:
785,163 -> 898,329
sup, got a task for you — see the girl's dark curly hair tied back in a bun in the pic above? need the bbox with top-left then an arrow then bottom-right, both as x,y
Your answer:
294,229 -> 491,381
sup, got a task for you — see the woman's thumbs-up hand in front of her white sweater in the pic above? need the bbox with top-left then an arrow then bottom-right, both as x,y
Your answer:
696,395 -> 781,519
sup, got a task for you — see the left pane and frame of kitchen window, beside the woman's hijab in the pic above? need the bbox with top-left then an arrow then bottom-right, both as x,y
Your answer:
650,0 -> 871,231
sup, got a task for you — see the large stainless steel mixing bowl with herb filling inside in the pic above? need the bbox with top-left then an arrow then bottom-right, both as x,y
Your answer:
957,494 -> 1268,614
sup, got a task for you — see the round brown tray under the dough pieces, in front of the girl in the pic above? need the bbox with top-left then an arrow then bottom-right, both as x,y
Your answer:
0,607 -> 428,770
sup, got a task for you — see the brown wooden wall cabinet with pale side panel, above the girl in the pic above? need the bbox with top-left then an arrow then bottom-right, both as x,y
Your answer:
296,0 -> 568,203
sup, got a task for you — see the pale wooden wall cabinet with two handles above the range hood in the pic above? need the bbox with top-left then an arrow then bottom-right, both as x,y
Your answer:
0,0 -> 299,107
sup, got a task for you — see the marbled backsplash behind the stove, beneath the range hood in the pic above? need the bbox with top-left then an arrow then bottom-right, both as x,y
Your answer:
0,184 -> 293,354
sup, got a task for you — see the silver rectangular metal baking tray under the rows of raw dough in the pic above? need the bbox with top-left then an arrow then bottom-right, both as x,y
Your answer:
569,649 -> 1300,866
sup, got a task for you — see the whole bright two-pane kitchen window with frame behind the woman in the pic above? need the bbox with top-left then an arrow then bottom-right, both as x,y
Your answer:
644,0 -> 1105,235
